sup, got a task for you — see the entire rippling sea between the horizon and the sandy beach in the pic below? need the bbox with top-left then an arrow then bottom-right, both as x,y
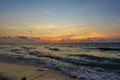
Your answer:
0,43 -> 120,80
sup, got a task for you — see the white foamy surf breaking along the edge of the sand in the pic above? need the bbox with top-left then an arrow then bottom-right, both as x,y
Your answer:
13,52 -> 120,80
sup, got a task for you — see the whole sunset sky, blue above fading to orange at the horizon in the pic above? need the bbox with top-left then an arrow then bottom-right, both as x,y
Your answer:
0,0 -> 120,43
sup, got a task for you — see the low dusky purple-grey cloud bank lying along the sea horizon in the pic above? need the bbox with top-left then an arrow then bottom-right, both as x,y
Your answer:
0,35 -> 120,43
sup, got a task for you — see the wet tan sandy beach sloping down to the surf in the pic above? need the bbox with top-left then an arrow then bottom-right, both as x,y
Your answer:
0,54 -> 77,80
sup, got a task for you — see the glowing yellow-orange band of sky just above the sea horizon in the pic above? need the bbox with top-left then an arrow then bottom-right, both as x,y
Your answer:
0,24 -> 120,43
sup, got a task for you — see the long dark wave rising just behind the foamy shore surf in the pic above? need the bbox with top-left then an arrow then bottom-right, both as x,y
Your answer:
12,50 -> 120,70
